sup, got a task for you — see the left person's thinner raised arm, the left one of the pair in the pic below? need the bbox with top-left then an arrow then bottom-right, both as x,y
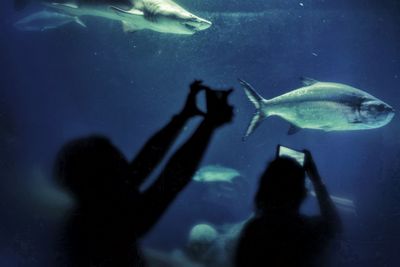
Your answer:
130,81 -> 204,188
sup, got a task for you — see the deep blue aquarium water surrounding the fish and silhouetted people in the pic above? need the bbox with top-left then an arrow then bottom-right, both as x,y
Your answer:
0,0 -> 400,266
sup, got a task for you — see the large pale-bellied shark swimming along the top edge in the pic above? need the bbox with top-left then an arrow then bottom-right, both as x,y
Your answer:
14,0 -> 212,35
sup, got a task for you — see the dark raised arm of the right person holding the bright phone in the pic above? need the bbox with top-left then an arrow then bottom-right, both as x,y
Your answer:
304,150 -> 342,234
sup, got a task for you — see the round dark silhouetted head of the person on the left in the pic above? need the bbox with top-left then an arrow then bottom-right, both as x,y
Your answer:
54,136 -> 128,202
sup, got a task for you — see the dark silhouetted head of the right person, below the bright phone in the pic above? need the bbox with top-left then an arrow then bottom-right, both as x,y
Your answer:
255,157 -> 307,215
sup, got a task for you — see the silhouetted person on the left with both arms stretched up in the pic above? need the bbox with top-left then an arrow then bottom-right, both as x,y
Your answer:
55,81 -> 233,267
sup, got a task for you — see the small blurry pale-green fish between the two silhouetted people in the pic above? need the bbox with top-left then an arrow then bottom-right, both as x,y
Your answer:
193,165 -> 240,183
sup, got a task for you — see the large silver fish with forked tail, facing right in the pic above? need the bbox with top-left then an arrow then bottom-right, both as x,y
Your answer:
239,78 -> 394,138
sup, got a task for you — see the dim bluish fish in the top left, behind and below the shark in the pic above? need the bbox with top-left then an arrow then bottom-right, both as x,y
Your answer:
14,10 -> 86,31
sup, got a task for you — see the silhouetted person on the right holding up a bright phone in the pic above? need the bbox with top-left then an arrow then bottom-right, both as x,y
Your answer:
236,151 -> 341,267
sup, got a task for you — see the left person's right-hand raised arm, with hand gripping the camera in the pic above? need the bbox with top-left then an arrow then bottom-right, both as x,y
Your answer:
138,86 -> 233,237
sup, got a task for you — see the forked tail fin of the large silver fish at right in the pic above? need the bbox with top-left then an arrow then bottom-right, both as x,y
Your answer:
239,79 -> 266,141
